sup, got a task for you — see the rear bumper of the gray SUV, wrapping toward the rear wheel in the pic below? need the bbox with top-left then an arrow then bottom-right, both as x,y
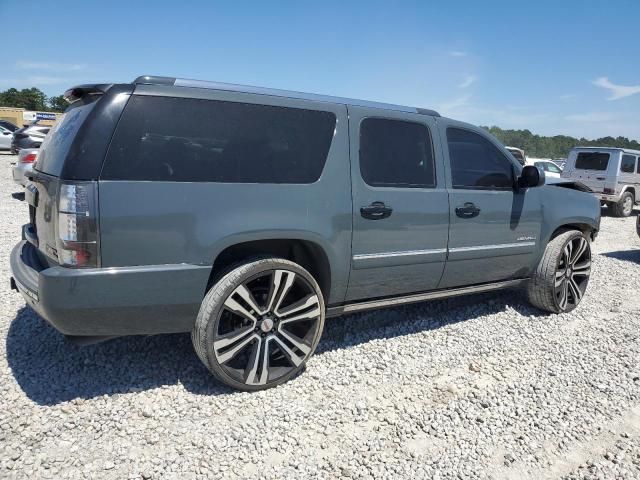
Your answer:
10,241 -> 211,336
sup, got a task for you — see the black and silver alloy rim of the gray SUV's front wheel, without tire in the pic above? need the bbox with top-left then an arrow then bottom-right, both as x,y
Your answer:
554,235 -> 591,311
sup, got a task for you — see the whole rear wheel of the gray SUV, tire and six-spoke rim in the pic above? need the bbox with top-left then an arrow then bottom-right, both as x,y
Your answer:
191,258 -> 325,391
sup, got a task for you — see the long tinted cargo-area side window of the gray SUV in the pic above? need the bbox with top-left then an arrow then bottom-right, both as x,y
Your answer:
102,95 -> 336,183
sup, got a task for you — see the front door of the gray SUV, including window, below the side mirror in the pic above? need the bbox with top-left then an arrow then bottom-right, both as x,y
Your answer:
438,119 -> 544,288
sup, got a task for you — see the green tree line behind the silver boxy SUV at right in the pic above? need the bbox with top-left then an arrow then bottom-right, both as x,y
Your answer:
482,126 -> 640,158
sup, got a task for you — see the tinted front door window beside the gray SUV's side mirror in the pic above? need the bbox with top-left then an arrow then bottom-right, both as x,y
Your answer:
447,128 -> 513,189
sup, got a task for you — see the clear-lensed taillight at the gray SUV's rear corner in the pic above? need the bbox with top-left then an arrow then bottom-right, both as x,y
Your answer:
57,182 -> 99,267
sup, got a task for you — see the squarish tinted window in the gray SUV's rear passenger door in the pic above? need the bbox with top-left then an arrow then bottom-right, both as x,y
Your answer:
360,118 -> 436,187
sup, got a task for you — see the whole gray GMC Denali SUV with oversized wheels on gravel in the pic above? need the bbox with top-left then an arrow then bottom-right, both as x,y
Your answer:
11,77 -> 600,390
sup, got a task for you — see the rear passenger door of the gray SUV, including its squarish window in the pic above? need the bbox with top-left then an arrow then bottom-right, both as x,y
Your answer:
347,107 -> 449,300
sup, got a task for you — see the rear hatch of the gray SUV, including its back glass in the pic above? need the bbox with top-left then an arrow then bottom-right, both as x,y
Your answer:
24,99 -> 97,265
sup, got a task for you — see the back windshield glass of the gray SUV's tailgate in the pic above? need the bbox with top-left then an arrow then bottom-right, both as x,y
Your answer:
35,98 -> 96,177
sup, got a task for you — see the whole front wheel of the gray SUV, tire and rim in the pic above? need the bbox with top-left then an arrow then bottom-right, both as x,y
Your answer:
528,230 -> 591,313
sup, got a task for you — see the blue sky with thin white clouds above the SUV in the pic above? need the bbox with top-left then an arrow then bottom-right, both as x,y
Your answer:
0,0 -> 640,139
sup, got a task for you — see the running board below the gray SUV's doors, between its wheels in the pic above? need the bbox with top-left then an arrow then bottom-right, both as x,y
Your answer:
325,278 -> 529,317
